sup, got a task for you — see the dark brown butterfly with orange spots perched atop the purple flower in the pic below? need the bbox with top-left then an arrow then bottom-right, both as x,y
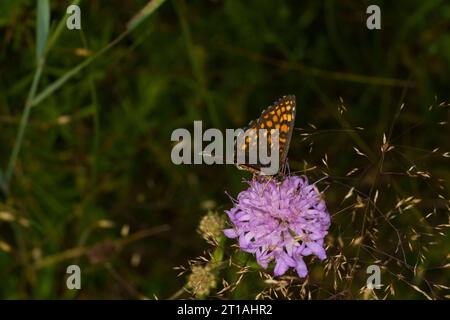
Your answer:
236,95 -> 295,175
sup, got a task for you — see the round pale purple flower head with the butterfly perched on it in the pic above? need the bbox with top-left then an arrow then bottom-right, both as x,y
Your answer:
224,176 -> 330,277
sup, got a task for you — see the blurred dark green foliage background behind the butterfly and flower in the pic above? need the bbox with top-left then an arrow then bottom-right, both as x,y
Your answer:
0,0 -> 450,299
